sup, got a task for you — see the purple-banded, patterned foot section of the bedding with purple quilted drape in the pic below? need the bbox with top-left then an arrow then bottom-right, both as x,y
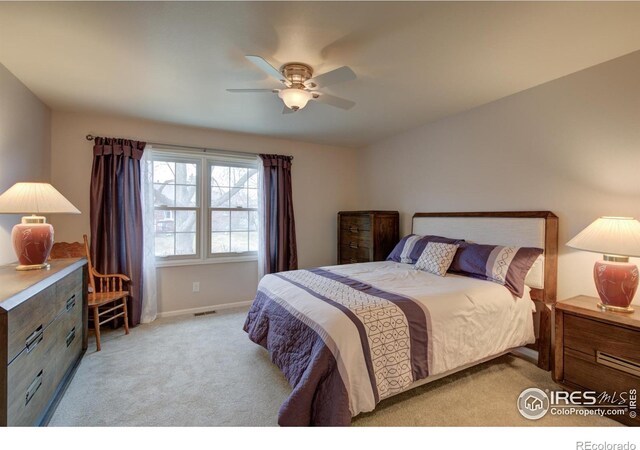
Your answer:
244,269 -> 429,426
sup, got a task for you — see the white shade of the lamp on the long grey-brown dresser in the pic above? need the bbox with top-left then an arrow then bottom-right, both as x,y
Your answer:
0,183 -> 80,214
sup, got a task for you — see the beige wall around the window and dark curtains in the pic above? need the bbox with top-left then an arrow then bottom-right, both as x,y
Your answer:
51,111 -> 357,313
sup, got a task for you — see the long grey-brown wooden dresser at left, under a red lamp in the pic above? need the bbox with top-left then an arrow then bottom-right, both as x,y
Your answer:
0,258 -> 87,426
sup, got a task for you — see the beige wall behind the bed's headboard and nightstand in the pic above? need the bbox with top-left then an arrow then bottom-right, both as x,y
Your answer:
360,52 -> 640,301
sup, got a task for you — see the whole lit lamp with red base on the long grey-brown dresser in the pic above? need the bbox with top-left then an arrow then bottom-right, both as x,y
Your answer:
0,183 -> 80,270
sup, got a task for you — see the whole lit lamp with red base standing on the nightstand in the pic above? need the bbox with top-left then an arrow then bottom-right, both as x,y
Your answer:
567,217 -> 640,313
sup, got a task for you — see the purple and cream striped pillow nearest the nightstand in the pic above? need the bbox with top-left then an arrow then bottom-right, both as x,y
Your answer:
449,242 -> 542,298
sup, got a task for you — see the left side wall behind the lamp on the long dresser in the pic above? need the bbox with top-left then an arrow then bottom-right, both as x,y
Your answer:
0,64 -> 50,265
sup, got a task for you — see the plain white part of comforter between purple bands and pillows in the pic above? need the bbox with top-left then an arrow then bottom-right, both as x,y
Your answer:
325,261 -> 535,376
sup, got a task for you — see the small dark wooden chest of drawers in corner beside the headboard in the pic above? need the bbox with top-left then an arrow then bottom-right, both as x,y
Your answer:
338,211 -> 399,264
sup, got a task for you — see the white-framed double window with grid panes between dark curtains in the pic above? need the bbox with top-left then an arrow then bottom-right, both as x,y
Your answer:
148,149 -> 259,261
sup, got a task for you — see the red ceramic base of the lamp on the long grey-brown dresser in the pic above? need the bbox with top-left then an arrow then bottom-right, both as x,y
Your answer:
11,217 -> 53,270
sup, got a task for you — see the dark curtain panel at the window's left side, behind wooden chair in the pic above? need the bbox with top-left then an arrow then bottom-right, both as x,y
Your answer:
90,137 -> 146,326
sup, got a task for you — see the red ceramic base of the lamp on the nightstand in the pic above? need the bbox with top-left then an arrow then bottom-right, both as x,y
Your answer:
593,261 -> 638,313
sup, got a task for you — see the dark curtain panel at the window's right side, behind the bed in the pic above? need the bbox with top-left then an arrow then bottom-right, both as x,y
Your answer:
260,155 -> 298,273
